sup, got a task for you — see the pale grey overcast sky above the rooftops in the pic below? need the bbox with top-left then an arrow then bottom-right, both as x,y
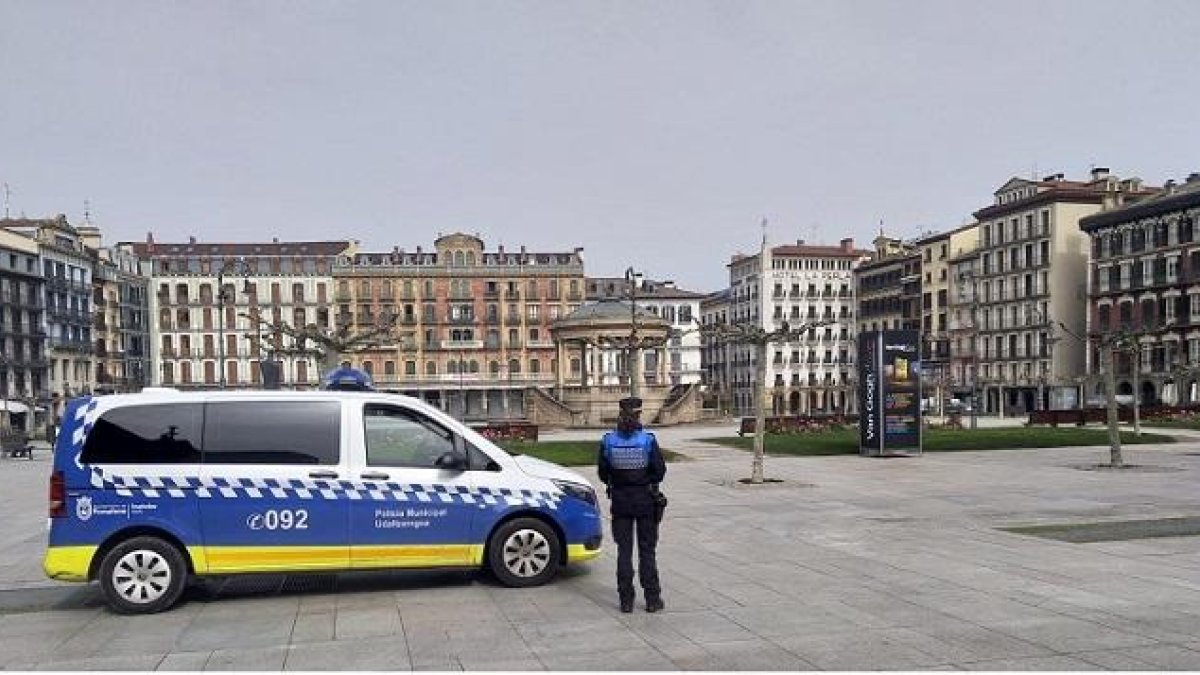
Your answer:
0,0 -> 1200,291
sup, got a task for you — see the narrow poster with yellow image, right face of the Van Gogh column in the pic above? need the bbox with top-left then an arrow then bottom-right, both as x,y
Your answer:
880,330 -> 922,453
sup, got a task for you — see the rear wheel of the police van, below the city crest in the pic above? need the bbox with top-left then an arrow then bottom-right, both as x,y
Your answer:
100,537 -> 187,614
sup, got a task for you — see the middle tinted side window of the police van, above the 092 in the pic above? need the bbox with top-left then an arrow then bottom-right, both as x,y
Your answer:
204,401 -> 342,465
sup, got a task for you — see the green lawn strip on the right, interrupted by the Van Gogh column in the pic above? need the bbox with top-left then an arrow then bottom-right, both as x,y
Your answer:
703,426 -> 1175,456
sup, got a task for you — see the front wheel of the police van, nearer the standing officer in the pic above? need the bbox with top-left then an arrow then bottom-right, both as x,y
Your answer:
487,518 -> 562,587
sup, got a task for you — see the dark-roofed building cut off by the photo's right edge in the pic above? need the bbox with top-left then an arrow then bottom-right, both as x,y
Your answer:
1080,173 -> 1200,405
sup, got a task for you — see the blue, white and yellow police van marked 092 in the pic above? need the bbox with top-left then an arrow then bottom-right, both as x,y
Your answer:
44,390 -> 601,614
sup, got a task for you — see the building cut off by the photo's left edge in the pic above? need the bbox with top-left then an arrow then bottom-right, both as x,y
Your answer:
0,223 -> 50,432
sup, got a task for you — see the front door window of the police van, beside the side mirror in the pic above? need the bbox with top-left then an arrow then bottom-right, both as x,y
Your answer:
362,405 -> 454,468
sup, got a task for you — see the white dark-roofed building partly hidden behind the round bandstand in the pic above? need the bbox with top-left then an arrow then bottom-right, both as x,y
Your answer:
586,277 -> 704,386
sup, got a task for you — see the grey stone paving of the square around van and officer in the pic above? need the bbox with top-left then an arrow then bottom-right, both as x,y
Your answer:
0,426 -> 1200,670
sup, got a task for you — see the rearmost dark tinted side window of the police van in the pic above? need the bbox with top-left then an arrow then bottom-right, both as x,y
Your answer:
80,404 -> 203,464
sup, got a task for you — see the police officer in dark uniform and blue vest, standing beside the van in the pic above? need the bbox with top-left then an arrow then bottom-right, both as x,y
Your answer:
596,396 -> 667,613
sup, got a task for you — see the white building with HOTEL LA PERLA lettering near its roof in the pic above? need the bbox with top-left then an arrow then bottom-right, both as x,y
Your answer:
728,239 -> 870,414
